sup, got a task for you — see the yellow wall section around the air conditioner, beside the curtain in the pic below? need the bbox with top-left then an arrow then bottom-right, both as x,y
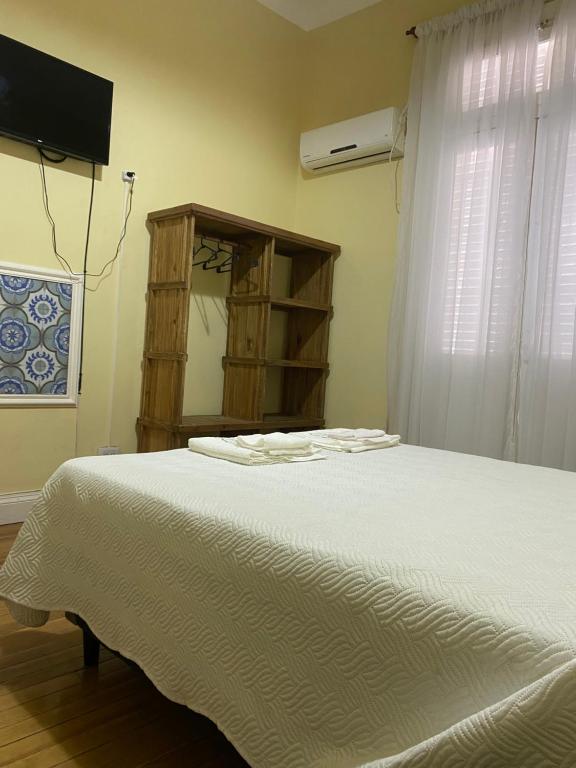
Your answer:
295,0 -> 463,427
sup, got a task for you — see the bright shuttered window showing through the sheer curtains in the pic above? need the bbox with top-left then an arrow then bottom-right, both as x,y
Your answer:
442,25 -> 564,357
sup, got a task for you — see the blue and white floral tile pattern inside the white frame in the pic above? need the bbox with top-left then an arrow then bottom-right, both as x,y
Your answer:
0,271 -> 72,397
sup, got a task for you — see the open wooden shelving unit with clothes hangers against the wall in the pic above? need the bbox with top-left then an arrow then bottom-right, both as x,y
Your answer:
137,203 -> 340,451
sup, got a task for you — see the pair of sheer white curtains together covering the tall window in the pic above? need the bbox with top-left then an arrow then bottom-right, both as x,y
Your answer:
389,0 -> 576,468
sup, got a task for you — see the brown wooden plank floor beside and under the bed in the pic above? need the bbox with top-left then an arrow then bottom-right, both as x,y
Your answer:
0,525 -> 247,768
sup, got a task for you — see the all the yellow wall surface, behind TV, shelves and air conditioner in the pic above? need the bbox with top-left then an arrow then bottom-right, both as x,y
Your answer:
0,0 -> 460,493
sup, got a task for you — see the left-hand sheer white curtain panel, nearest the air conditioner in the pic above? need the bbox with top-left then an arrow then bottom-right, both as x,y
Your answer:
389,0 -> 544,458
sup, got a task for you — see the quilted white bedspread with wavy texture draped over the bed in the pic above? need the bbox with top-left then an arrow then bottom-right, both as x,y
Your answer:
0,446 -> 576,768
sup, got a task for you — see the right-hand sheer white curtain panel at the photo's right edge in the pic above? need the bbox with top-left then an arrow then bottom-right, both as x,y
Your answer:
517,0 -> 576,470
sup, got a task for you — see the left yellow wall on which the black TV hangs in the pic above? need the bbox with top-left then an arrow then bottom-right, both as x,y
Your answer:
0,0 -> 306,493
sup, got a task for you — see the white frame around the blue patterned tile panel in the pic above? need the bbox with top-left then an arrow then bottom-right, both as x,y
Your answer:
0,261 -> 84,408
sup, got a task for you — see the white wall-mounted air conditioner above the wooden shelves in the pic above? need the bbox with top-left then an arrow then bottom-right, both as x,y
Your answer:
300,107 -> 404,173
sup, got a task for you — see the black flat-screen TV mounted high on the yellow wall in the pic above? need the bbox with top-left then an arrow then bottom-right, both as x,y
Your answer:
0,35 -> 114,165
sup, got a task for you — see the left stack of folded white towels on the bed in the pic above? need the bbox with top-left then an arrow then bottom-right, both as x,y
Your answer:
188,432 -> 324,466
